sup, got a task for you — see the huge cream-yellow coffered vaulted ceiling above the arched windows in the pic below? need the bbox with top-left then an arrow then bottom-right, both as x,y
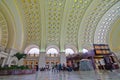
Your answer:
0,0 -> 120,52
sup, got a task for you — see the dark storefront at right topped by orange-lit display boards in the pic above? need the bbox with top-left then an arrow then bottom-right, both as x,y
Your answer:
93,44 -> 119,70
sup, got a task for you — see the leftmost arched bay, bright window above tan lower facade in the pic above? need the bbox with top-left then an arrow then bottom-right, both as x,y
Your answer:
24,45 -> 40,69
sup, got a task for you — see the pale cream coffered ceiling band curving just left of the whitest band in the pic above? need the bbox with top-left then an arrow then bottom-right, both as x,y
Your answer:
78,0 -> 119,47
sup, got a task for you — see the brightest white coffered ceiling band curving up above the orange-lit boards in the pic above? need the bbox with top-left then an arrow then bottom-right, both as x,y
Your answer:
94,2 -> 120,43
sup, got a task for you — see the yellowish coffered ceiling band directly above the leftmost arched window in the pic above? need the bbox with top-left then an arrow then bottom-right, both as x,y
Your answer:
18,0 -> 41,45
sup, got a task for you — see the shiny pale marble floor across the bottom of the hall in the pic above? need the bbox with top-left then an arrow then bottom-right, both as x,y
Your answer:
0,70 -> 120,80
